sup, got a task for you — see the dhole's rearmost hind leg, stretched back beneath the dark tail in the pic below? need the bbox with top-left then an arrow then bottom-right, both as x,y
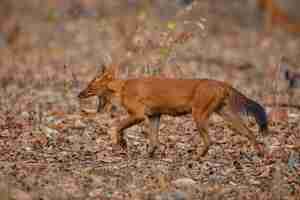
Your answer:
218,107 -> 262,153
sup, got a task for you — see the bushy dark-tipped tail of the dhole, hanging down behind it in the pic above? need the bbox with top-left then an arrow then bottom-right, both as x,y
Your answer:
230,91 -> 268,133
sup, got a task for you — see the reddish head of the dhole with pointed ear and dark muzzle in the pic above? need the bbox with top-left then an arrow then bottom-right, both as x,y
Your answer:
78,66 -> 115,99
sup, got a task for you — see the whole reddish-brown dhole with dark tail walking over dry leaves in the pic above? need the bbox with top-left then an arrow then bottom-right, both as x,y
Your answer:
78,66 -> 268,158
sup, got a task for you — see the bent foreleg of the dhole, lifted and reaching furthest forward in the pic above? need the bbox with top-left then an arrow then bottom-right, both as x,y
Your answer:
111,115 -> 145,149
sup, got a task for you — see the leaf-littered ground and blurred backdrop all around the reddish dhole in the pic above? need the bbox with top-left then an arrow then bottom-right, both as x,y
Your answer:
0,0 -> 300,200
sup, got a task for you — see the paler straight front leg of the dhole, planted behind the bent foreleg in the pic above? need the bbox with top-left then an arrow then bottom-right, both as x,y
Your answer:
148,115 -> 160,157
